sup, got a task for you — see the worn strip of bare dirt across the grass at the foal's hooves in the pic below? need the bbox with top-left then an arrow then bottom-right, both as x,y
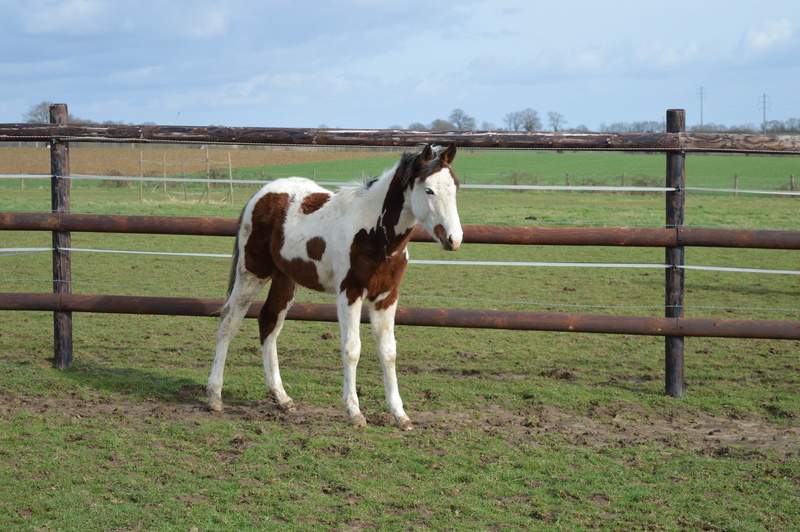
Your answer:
0,386 -> 800,457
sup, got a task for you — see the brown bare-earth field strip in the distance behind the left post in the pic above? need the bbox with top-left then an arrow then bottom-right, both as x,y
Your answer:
0,145 -> 396,176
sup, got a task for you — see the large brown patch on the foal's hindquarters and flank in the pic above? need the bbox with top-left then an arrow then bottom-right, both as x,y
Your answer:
244,192 -> 325,292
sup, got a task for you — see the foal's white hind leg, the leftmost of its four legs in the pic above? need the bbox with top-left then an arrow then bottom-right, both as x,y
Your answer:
206,272 -> 267,411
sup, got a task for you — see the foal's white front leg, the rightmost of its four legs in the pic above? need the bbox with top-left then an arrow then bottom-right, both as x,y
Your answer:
369,303 -> 414,430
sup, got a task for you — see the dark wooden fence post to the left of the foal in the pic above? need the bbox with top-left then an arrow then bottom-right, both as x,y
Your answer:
50,103 -> 72,370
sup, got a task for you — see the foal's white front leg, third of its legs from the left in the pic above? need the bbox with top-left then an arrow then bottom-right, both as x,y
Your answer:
336,292 -> 367,427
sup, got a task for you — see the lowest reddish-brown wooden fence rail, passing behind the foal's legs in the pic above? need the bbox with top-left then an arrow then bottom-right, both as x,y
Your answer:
0,293 -> 800,340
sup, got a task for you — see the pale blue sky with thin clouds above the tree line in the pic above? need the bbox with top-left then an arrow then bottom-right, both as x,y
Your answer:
0,0 -> 800,131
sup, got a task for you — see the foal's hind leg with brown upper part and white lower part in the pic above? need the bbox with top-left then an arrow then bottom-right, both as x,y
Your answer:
258,272 -> 295,410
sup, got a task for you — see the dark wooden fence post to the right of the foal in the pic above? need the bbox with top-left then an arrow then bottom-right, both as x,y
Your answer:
664,109 -> 686,397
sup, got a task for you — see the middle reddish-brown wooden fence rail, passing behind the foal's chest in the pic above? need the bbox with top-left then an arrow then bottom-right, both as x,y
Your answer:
0,213 -> 800,249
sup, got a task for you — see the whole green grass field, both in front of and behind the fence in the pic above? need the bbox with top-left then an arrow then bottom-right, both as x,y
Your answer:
0,145 -> 800,530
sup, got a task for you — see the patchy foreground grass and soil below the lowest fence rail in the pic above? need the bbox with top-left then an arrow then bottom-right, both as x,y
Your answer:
0,313 -> 800,530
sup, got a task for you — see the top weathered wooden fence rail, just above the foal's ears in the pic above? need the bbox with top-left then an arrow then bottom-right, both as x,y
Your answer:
0,124 -> 800,154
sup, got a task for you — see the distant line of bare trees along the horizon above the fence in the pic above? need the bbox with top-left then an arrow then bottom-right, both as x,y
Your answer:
23,102 -> 800,135
